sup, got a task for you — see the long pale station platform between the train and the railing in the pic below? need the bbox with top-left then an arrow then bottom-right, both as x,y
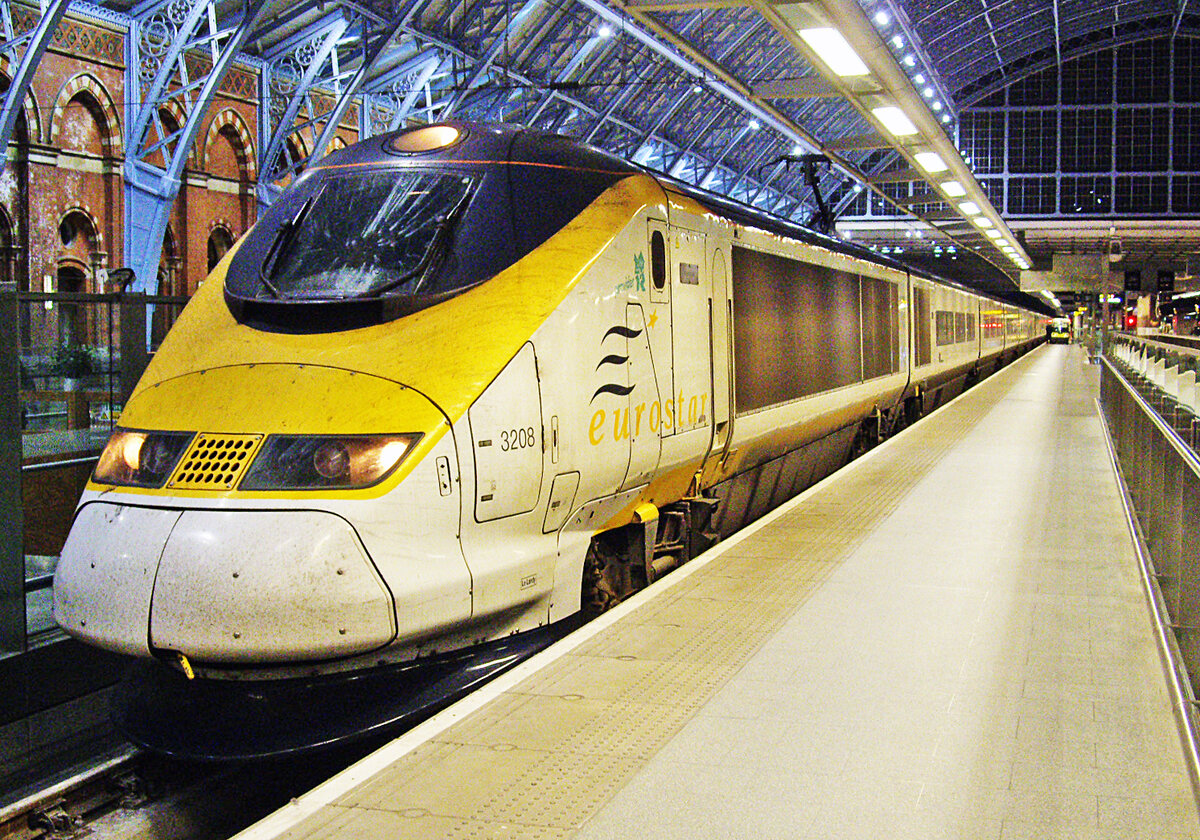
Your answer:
239,346 -> 1200,840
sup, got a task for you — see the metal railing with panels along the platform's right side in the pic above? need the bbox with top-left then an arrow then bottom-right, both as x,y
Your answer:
1100,336 -> 1200,797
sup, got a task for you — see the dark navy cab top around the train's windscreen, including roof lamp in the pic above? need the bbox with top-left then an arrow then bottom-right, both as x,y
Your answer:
226,121 -> 640,332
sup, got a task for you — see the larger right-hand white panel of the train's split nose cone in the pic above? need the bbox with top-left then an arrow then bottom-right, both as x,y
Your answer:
150,510 -> 396,664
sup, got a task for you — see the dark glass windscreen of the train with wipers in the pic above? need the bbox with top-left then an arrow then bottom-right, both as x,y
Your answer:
262,169 -> 473,300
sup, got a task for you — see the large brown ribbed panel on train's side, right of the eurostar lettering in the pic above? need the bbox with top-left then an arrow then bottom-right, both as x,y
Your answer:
732,247 -> 873,413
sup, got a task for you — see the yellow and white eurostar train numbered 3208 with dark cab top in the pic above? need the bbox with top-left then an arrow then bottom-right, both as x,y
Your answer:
54,122 -> 1045,682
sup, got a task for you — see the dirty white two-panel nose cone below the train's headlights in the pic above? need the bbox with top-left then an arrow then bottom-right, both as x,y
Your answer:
54,502 -> 396,664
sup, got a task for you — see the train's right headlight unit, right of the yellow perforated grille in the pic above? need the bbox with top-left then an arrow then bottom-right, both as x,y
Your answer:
240,434 -> 421,490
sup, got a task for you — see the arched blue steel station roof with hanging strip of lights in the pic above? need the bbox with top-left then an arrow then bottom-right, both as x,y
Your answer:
63,0 -> 1200,304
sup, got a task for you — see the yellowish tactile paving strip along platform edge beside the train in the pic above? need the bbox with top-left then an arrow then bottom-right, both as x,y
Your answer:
284,360 -> 1032,840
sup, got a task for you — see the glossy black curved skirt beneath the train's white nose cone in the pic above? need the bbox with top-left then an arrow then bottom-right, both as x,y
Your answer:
113,617 -> 580,761
